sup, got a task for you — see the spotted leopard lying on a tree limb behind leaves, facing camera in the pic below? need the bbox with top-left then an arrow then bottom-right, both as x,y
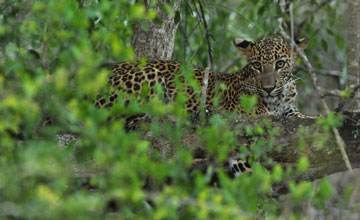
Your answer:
95,37 -> 309,176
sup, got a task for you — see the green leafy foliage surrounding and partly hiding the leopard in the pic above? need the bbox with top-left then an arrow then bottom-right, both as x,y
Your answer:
0,0 -> 354,219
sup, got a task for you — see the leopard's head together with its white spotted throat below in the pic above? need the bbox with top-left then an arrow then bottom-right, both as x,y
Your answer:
233,38 -> 309,115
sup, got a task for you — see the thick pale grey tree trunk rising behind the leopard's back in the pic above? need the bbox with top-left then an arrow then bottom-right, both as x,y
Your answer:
131,0 -> 180,60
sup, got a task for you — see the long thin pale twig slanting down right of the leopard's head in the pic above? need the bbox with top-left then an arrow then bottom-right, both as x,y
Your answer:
278,18 -> 352,173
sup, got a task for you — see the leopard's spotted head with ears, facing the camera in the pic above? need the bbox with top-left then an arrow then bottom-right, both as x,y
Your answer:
233,37 -> 309,97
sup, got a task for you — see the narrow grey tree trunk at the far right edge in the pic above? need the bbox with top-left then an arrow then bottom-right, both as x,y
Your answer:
347,0 -> 360,110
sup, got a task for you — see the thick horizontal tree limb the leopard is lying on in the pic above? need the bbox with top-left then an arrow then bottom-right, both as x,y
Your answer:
67,112 -> 360,194
